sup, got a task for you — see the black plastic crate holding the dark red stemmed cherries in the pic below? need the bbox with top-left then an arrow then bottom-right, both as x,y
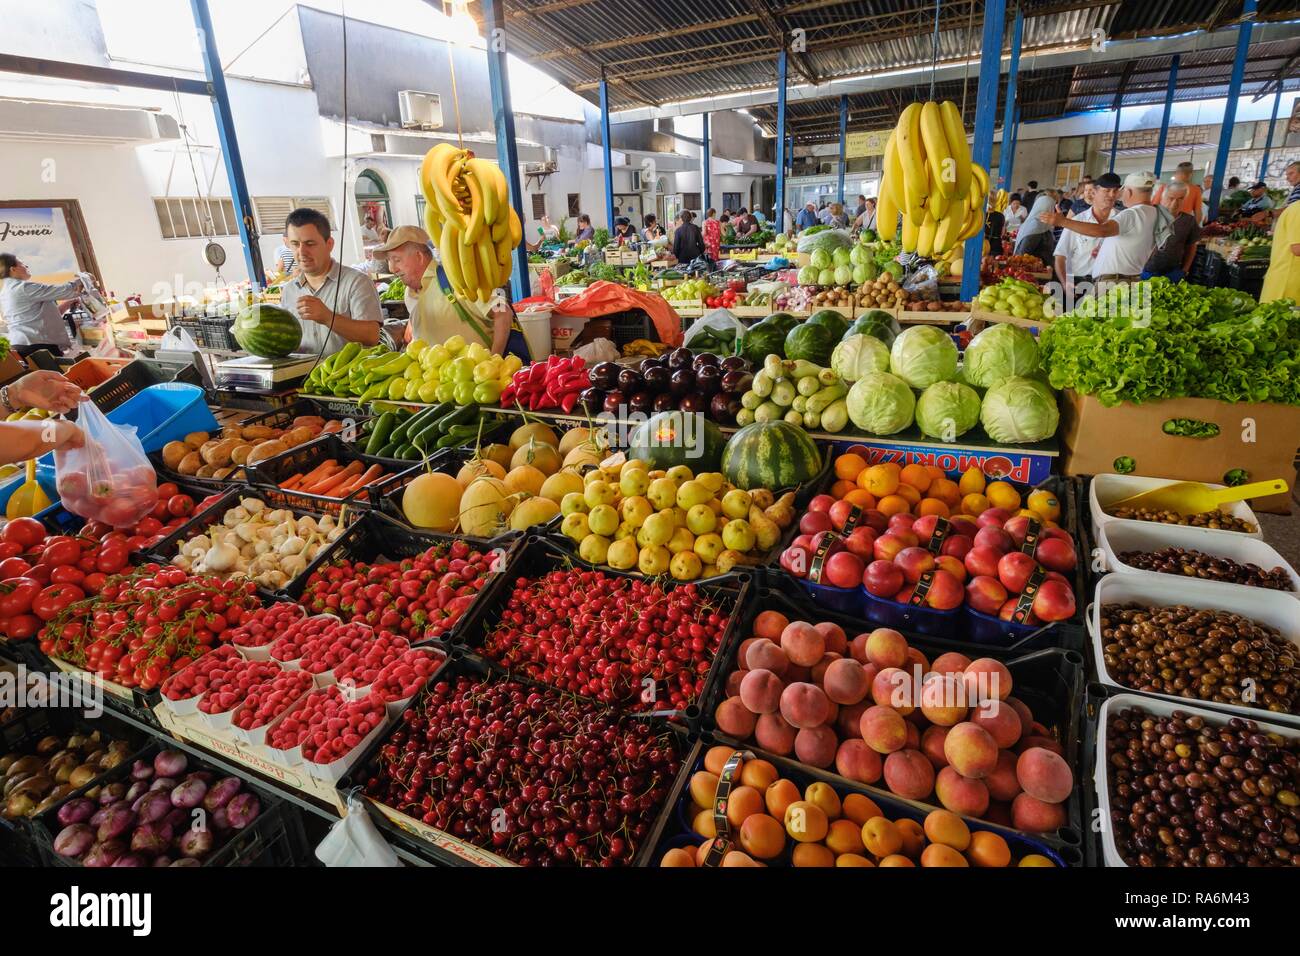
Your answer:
339,652 -> 699,866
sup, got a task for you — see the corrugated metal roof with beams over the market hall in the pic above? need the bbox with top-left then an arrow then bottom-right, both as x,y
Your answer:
475,0 -> 1300,144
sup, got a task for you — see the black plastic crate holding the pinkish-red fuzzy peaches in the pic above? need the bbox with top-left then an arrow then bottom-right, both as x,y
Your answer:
701,591 -> 1088,847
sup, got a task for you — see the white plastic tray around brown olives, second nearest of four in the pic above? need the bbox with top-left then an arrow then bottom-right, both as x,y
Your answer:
1088,574 -> 1300,726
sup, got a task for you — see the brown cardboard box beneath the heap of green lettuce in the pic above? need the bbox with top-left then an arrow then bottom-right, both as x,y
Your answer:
1060,389 -> 1300,515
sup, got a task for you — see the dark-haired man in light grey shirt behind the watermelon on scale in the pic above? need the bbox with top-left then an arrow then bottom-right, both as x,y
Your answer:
280,208 -> 384,355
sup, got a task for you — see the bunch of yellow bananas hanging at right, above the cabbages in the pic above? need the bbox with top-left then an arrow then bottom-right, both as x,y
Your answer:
876,100 -> 988,259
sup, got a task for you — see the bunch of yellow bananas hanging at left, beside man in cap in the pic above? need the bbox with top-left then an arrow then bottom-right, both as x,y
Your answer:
420,143 -> 524,302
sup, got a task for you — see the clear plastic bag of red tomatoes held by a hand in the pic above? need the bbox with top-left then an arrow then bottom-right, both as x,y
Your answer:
55,402 -> 159,528
